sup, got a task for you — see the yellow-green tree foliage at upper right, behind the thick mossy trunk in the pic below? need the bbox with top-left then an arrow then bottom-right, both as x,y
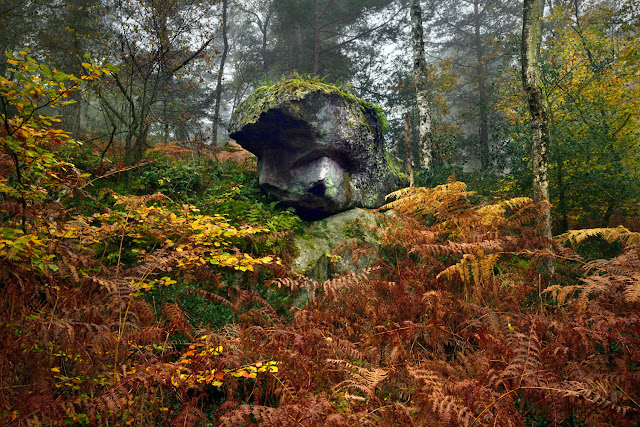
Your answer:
496,0 -> 640,157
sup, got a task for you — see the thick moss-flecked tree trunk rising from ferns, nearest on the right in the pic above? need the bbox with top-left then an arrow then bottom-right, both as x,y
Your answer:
522,0 -> 552,244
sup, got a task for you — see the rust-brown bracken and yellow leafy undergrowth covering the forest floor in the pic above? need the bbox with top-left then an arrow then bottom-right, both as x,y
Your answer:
0,52 -> 640,426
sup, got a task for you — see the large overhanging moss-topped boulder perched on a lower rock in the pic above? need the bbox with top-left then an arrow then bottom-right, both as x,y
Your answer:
229,78 -> 399,220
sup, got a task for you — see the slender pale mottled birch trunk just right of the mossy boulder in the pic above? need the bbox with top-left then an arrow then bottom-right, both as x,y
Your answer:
410,0 -> 433,170
